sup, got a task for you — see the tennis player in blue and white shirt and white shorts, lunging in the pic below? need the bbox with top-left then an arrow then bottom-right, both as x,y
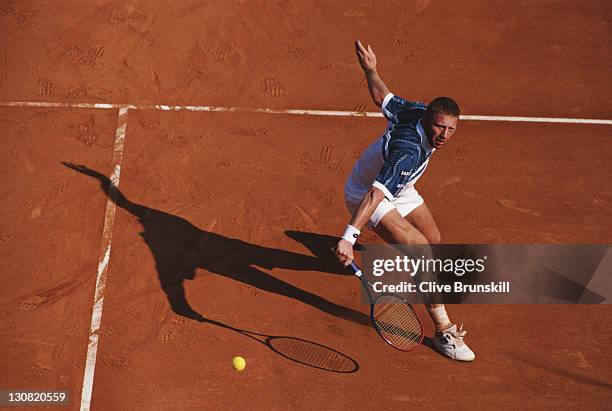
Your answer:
335,41 -> 475,361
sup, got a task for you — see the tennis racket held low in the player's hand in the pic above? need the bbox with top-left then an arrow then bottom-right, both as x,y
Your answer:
351,262 -> 423,351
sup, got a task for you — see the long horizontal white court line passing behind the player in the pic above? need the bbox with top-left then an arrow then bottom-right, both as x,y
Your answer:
0,101 -> 612,125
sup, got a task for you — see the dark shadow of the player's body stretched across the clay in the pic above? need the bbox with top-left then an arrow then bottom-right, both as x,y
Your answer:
63,162 -> 370,326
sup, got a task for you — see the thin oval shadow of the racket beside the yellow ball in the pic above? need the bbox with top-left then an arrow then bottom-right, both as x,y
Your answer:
200,318 -> 359,374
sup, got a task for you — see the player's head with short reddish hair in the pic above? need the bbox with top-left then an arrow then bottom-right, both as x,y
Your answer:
421,97 -> 461,148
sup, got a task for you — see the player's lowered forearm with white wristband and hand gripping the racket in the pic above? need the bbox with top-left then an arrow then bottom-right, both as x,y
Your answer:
334,187 -> 385,266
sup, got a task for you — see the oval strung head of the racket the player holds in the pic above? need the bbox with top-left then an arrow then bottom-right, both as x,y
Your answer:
374,296 -> 423,350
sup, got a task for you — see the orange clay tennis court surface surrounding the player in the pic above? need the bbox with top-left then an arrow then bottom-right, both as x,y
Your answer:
0,0 -> 612,410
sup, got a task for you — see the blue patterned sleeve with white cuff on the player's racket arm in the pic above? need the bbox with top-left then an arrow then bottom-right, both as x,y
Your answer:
372,135 -> 421,200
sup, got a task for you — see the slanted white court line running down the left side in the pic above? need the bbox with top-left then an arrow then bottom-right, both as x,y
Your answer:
81,107 -> 128,411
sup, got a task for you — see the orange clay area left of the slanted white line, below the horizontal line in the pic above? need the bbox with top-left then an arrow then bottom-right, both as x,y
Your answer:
0,108 -> 117,402
